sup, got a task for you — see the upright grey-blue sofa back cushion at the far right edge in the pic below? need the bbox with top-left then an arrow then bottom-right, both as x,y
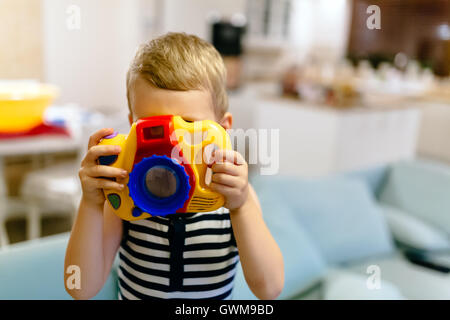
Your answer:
379,161 -> 450,235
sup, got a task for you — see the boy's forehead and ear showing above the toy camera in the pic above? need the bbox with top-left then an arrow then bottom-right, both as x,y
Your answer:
130,77 -> 231,129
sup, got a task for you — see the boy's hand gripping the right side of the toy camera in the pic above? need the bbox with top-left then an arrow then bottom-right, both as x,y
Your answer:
208,150 -> 248,211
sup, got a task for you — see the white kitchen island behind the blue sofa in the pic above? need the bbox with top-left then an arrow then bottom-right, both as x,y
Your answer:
230,85 -> 421,177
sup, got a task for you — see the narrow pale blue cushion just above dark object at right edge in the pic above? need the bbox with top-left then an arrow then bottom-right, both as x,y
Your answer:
380,204 -> 450,250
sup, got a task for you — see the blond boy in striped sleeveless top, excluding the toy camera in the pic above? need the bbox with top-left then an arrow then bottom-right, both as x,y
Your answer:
65,33 -> 284,299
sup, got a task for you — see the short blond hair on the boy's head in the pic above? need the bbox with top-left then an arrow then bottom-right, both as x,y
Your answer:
127,33 -> 228,116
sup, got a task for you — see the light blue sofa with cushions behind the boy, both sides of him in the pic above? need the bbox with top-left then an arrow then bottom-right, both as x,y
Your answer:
0,161 -> 450,299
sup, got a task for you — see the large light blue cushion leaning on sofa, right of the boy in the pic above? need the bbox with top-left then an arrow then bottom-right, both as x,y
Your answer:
253,176 -> 393,264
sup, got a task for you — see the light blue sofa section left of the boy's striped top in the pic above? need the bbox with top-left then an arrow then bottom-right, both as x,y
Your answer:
0,234 -> 117,300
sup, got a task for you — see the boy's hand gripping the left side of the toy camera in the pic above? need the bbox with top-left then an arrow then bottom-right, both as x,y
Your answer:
78,129 -> 128,206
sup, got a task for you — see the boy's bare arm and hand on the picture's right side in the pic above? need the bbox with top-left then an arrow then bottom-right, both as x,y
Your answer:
210,150 -> 284,299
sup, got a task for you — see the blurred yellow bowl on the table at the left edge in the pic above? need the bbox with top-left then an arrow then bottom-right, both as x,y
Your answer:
0,84 -> 58,133
